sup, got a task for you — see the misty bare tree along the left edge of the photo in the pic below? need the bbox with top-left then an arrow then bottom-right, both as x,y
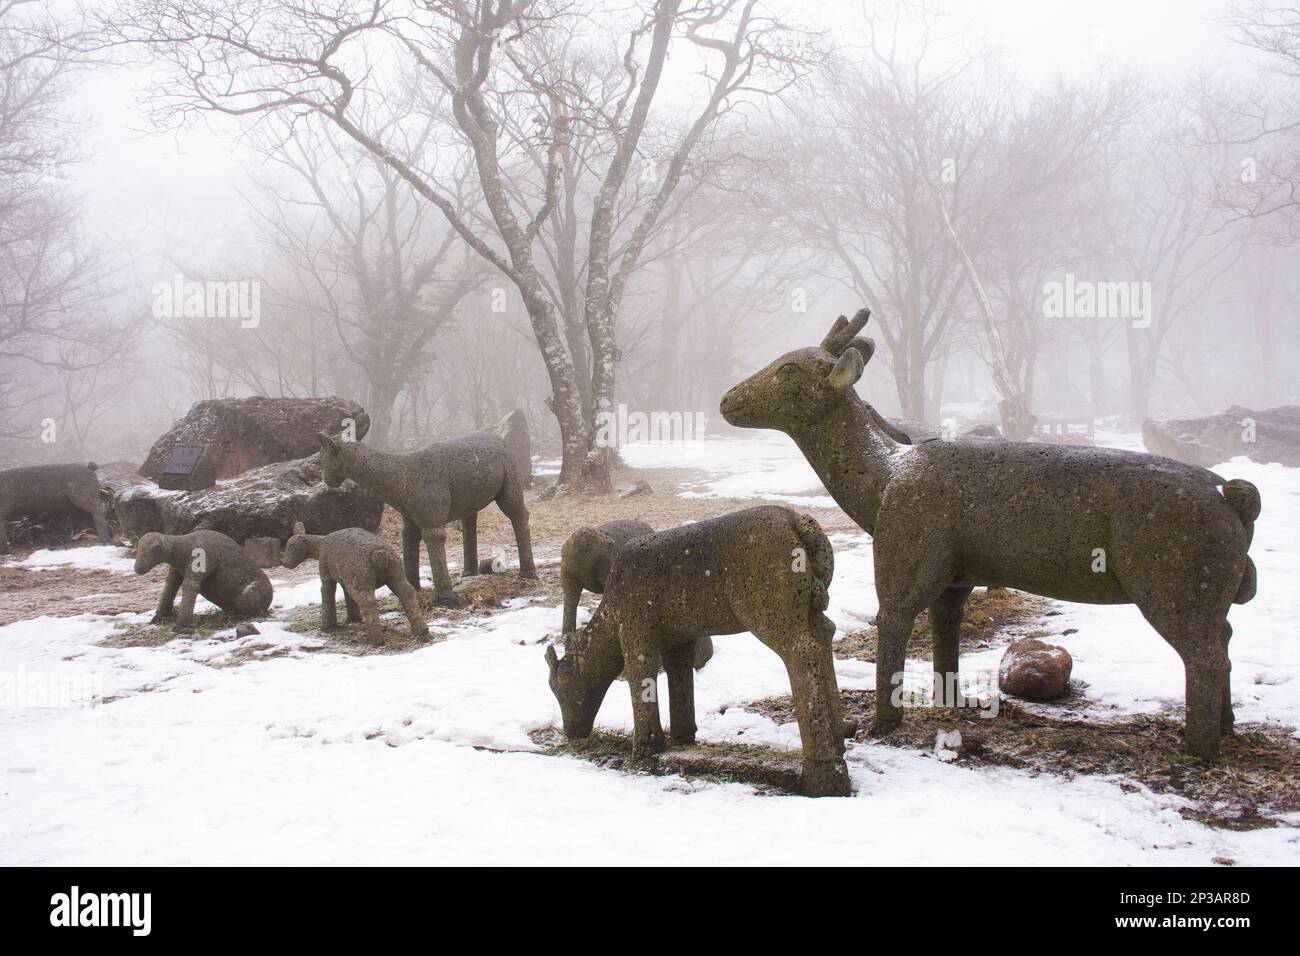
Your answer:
0,0 -> 139,457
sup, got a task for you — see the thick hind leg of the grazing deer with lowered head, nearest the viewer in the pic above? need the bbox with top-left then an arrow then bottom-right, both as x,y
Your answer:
758,623 -> 853,796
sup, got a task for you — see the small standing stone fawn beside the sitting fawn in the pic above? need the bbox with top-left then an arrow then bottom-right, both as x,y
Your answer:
282,522 -> 429,645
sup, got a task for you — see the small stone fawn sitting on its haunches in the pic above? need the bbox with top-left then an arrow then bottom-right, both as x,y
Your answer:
135,531 -> 274,631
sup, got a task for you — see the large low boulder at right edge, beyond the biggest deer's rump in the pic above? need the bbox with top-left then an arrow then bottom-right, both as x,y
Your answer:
1141,405 -> 1300,468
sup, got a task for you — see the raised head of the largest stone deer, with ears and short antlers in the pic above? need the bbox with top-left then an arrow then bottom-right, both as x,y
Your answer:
720,308 -> 876,433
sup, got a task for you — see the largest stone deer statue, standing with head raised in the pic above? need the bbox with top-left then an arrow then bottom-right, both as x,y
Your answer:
720,308 -> 1260,760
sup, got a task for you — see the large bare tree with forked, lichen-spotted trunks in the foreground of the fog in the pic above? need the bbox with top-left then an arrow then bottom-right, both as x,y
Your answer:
101,0 -> 800,483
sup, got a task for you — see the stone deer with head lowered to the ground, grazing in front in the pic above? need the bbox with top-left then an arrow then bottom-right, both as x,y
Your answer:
546,506 -> 850,796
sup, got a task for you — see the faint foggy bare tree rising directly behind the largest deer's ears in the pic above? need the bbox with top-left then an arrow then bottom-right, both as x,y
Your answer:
768,3 -> 972,420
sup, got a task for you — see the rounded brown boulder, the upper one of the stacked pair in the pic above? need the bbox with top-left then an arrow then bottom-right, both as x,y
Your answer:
140,395 -> 369,490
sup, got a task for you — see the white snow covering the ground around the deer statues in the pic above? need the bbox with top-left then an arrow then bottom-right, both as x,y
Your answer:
0,436 -> 1300,865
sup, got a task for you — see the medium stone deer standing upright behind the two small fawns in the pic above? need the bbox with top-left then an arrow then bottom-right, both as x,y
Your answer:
320,432 -> 537,606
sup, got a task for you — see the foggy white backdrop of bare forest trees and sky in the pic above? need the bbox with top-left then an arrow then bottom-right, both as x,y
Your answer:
0,0 -> 1300,477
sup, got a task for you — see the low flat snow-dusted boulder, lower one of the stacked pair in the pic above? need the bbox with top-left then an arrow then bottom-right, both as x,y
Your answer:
100,454 -> 384,544
